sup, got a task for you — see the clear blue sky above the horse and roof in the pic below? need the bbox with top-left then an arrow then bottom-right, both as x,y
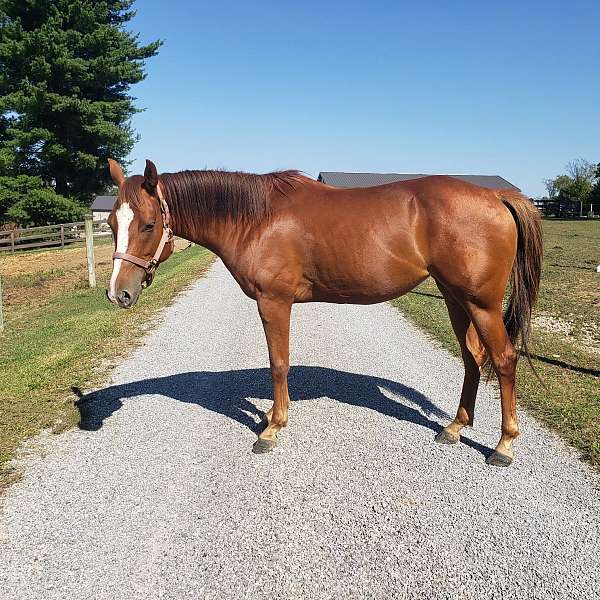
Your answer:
129,0 -> 600,195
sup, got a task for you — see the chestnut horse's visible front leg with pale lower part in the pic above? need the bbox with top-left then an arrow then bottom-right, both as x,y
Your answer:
252,297 -> 292,454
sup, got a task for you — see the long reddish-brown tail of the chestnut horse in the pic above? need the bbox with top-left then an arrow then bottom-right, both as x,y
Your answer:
497,190 -> 543,372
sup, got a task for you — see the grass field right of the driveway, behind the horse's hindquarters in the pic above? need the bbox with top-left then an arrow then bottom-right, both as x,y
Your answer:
394,220 -> 600,466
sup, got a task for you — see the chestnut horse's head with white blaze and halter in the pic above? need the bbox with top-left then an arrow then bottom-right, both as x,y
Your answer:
107,159 -> 173,308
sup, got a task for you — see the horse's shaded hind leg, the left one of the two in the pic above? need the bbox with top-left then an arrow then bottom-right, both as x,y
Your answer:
435,282 -> 485,444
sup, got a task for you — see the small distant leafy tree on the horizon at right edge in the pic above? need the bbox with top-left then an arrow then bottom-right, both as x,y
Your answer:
544,158 -> 600,216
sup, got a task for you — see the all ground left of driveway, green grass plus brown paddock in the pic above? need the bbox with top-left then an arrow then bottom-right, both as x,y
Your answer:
0,242 -> 213,488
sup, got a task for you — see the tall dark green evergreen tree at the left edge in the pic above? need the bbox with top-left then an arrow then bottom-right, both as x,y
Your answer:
0,0 -> 161,226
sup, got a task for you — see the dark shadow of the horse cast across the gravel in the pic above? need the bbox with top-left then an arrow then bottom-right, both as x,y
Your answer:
75,366 -> 492,456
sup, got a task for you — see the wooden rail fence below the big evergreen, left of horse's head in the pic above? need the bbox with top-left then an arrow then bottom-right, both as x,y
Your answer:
0,221 -> 110,252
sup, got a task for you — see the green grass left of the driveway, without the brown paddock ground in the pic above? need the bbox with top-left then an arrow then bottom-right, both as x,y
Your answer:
0,246 -> 213,487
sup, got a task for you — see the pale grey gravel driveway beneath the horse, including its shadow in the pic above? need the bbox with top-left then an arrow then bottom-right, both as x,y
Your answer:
0,262 -> 600,600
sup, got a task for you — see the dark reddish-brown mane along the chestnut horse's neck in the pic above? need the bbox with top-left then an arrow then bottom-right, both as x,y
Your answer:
159,171 -> 305,222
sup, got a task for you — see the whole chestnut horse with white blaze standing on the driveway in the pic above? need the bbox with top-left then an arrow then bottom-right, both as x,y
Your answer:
107,160 -> 542,466
